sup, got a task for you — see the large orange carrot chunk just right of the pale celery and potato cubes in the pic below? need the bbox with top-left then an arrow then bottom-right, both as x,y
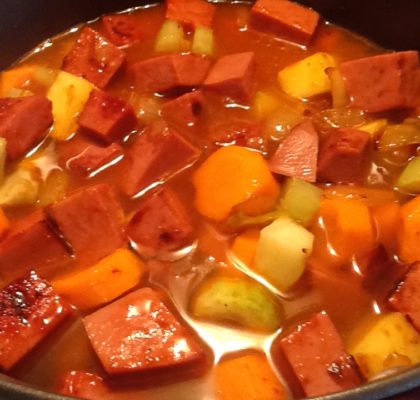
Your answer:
320,199 -> 376,259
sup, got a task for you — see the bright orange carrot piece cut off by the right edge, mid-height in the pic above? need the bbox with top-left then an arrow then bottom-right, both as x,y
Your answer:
398,196 -> 420,263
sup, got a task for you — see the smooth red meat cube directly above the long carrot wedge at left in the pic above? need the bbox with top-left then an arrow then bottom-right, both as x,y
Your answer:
49,183 -> 124,266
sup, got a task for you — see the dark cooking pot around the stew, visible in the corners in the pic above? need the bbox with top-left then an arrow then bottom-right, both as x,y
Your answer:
0,0 -> 420,400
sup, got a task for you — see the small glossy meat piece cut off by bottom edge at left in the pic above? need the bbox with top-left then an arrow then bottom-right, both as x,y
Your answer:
57,371 -> 110,400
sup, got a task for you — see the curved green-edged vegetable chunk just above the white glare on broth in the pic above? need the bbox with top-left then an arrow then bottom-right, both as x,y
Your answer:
192,277 -> 280,332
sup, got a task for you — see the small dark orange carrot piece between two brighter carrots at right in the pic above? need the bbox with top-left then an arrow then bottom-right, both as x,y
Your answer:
371,203 -> 401,252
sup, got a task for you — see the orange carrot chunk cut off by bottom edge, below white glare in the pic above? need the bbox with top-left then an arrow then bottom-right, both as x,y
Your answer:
216,353 -> 288,400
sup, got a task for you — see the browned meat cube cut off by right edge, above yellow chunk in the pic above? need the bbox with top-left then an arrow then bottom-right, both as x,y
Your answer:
389,263 -> 420,332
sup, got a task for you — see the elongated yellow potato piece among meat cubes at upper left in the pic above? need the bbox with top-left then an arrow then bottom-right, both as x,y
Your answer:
47,71 -> 94,140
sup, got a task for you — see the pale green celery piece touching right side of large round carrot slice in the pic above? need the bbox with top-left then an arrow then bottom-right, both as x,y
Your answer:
281,178 -> 322,226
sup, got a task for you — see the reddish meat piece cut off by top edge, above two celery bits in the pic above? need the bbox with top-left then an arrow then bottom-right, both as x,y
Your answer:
166,0 -> 215,30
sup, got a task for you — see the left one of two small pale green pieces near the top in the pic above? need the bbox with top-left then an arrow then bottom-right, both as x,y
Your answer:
155,20 -> 190,53
